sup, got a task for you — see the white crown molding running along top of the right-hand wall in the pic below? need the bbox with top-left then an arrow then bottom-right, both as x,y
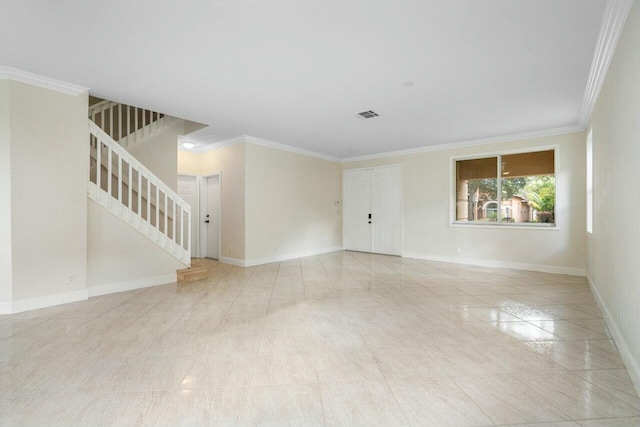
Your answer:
578,0 -> 633,127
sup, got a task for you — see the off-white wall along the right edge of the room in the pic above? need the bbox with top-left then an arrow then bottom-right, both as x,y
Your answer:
587,2 -> 640,390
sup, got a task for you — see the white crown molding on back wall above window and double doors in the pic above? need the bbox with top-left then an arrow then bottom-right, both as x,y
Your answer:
340,125 -> 584,163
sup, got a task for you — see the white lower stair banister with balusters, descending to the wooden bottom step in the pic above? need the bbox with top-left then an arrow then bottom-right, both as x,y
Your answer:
88,120 -> 191,266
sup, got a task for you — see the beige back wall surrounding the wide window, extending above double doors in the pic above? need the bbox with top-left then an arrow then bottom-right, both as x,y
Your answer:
342,132 -> 585,274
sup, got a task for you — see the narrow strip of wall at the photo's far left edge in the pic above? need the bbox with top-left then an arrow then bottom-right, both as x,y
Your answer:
0,80 -> 12,313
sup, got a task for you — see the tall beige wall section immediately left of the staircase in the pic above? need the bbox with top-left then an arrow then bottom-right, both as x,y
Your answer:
9,81 -> 89,303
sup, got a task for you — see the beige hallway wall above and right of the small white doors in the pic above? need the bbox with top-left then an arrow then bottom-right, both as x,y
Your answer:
178,143 -> 245,261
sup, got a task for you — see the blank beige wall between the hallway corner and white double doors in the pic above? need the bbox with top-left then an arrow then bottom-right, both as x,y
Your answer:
246,144 -> 342,264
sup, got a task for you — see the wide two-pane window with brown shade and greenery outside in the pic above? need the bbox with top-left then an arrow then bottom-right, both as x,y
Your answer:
455,150 -> 556,226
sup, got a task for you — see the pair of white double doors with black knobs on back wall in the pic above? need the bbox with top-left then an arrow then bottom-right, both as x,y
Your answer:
343,166 -> 402,255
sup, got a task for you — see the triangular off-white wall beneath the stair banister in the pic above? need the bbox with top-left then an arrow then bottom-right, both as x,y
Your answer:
85,200 -> 185,296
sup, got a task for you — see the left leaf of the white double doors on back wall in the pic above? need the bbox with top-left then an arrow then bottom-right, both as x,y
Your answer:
342,169 -> 372,252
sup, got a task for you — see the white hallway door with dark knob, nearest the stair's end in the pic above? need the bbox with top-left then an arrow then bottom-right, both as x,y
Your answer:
199,174 -> 221,260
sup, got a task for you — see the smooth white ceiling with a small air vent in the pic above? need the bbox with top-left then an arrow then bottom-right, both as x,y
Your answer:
0,0 -> 606,158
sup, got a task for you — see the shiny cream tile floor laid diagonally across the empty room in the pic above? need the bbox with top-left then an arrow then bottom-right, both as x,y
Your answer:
0,252 -> 640,426
